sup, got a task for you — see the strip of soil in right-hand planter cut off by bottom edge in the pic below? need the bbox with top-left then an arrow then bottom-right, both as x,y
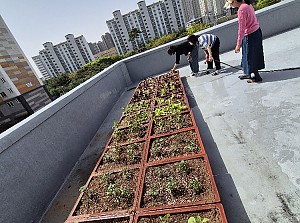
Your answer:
138,208 -> 222,223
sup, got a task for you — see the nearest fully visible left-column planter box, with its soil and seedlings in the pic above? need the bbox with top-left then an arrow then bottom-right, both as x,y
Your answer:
68,167 -> 142,222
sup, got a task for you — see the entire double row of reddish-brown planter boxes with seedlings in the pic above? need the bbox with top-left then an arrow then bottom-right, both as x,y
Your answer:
66,73 -> 227,223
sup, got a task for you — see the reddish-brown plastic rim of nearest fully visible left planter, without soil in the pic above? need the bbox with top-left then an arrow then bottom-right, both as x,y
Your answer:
66,167 -> 142,222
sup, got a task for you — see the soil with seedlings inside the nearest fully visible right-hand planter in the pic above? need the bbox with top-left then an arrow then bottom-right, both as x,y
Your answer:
141,158 -> 216,208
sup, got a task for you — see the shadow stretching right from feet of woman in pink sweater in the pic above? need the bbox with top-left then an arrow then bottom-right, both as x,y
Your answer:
260,69 -> 300,83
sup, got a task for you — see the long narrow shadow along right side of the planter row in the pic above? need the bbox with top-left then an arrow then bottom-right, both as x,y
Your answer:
182,77 -> 250,223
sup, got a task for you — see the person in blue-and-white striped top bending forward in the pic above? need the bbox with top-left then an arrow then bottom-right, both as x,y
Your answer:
188,34 -> 221,75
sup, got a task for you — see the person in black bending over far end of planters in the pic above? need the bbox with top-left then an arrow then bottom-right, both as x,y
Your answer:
168,42 -> 199,76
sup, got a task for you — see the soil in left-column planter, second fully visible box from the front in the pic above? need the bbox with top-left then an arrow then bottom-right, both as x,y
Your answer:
97,142 -> 145,171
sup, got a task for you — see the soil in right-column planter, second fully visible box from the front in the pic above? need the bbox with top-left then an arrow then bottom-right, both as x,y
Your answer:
149,131 -> 201,161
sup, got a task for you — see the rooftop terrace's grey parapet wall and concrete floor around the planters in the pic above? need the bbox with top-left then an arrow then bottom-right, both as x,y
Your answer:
0,0 -> 300,222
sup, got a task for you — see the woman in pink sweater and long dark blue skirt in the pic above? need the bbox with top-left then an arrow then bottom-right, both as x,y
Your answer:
226,0 -> 265,83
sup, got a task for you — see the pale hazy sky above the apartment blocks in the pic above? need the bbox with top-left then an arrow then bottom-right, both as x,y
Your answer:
0,0 -> 155,74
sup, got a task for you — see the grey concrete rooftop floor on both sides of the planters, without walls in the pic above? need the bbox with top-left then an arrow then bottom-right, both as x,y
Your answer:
42,28 -> 300,223
